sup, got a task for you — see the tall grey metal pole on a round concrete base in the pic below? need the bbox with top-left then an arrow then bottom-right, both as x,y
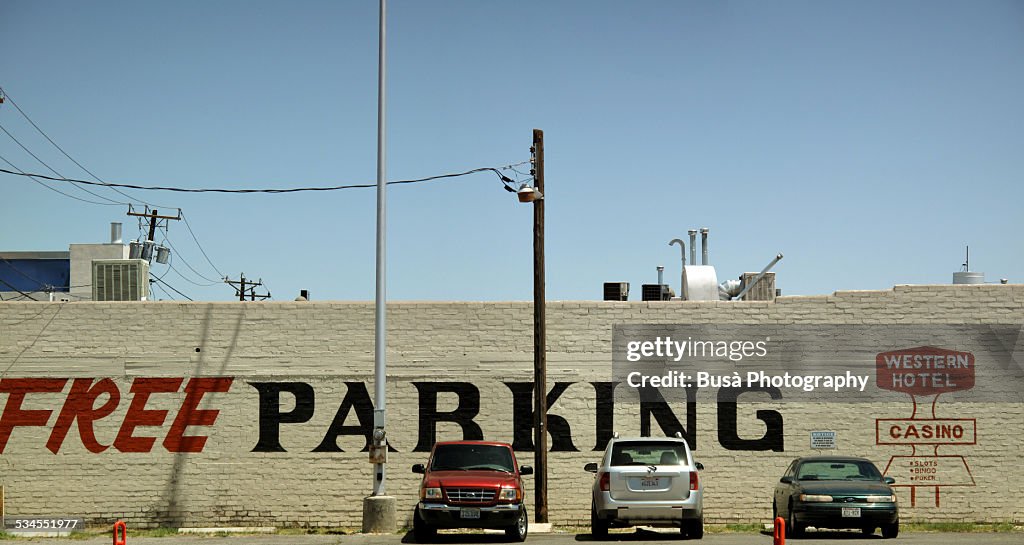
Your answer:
362,0 -> 396,534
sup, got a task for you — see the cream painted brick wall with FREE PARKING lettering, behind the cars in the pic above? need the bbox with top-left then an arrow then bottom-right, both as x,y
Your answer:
0,285 -> 1024,527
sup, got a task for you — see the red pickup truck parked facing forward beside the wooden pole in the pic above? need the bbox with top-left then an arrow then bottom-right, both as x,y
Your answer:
413,441 -> 534,543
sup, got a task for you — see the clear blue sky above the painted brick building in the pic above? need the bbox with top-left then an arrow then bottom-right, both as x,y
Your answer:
0,0 -> 1024,300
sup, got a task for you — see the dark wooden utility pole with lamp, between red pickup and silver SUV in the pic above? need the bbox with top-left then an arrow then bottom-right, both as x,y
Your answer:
530,129 -> 548,522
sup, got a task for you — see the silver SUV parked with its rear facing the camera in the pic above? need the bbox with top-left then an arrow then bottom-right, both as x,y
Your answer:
584,434 -> 703,539
